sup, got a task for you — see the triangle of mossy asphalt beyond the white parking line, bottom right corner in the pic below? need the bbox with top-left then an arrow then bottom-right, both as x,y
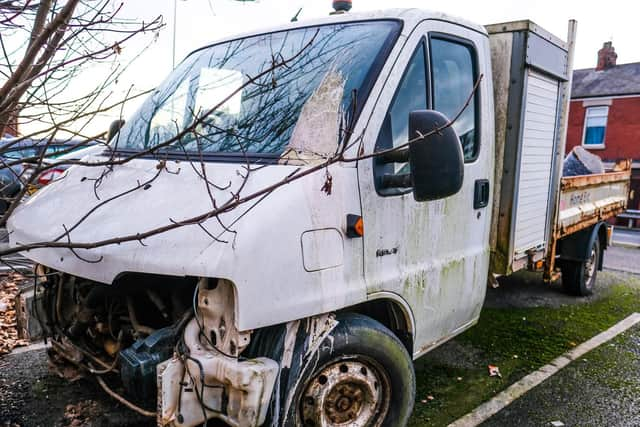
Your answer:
482,327 -> 640,427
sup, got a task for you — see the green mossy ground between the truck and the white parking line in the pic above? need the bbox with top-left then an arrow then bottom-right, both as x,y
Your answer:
409,283 -> 640,427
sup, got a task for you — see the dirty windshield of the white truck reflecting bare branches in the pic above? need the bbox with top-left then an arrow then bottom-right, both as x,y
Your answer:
116,21 -> 398,155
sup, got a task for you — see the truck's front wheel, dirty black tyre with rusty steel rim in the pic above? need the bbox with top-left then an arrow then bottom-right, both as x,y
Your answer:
265,313 -> 415,427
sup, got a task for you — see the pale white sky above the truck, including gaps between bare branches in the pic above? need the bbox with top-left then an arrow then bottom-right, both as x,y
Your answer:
36,0 -> 640,133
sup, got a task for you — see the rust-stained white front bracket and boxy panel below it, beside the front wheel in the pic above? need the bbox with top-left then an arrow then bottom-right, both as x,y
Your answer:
158,279 -> 278,427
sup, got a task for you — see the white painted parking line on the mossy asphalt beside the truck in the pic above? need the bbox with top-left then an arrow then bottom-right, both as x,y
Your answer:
448,313 -> 640,427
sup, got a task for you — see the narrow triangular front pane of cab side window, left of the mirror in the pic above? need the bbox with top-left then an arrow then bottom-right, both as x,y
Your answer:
374,42 -> 427,195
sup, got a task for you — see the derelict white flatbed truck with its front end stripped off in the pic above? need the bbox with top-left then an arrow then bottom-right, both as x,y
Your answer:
9,9 -> 630,427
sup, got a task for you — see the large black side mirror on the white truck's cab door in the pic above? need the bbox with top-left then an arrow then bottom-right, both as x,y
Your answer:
409,110 -> 464,202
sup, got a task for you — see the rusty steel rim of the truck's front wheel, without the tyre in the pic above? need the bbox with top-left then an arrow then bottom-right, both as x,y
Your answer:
300,360 -> 390,427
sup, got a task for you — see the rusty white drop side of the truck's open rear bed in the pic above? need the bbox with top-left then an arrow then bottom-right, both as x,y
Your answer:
554,161 -> 631,239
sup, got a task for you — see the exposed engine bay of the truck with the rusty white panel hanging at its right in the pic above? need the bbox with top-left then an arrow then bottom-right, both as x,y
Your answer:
33,266 -> 279,426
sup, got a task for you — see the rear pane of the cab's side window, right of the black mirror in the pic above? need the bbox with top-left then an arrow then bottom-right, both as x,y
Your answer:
430,37 -> 479,162
